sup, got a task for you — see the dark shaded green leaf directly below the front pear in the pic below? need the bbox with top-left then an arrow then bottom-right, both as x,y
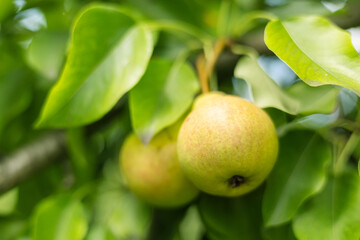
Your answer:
198,188 -> 263,240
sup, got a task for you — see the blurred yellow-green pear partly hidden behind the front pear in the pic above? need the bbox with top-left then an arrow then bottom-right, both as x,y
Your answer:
120,124 -> 199,208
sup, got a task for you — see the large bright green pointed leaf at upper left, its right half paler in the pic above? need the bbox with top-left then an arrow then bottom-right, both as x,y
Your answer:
37,5 -> 154,127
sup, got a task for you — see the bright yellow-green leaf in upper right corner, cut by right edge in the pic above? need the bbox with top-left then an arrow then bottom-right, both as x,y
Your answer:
265,16 -> 360,95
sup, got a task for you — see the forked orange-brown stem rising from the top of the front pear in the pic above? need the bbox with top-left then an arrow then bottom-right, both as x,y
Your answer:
196,38 -> 227,93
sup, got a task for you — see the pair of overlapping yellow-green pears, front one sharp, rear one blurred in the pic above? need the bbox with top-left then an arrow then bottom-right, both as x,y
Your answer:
120,92 -> 278,207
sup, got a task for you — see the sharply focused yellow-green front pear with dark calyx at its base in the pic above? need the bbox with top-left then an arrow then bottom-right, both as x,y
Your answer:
177,92 -> 278,197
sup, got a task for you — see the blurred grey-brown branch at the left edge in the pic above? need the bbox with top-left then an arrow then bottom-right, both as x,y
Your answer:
0,132 -> 65,194
